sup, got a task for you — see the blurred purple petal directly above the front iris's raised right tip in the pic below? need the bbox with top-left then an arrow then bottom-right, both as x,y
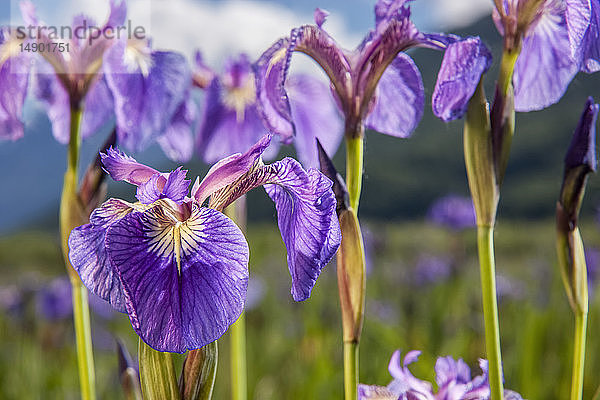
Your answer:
196,79 -> 274,163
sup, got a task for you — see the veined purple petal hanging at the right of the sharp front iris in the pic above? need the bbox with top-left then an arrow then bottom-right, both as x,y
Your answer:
264,158 -> 341,301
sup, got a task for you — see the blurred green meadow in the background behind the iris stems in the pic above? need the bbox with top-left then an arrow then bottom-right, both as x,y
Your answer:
0,221 -> 600,399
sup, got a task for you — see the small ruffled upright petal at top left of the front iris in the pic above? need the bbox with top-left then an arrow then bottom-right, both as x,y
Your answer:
100,147 -> 160,186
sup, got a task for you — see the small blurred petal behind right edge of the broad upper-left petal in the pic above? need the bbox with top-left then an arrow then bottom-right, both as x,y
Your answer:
156,97 -> 196,162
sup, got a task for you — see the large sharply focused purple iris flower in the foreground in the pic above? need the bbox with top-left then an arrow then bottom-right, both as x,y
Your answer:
69,136 -> 341,353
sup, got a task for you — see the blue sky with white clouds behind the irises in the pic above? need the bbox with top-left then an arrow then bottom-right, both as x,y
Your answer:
0,0 -> 492,234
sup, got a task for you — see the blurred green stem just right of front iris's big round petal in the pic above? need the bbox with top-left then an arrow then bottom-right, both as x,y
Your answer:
225,202 -> 248,400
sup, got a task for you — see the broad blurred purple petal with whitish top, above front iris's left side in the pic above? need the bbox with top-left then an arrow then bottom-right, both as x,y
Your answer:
104,42 -> 191,151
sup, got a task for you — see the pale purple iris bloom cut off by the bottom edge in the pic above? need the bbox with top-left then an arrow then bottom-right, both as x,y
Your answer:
358,350 -> 522,400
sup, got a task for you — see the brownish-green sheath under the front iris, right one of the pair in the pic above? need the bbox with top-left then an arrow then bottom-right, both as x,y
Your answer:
179,341 -> 219,400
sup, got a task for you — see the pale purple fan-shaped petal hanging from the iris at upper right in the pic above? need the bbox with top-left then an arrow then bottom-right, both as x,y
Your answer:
513,7 -> 579,111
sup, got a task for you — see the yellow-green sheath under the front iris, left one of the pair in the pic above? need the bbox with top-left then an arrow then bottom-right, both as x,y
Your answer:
138,339 -> 181,400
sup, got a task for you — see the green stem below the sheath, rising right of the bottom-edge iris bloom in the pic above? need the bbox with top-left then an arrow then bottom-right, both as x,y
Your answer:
477,225 -> 504,400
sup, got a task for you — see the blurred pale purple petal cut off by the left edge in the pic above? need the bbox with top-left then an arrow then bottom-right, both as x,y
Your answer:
0,29 -> 31,140
